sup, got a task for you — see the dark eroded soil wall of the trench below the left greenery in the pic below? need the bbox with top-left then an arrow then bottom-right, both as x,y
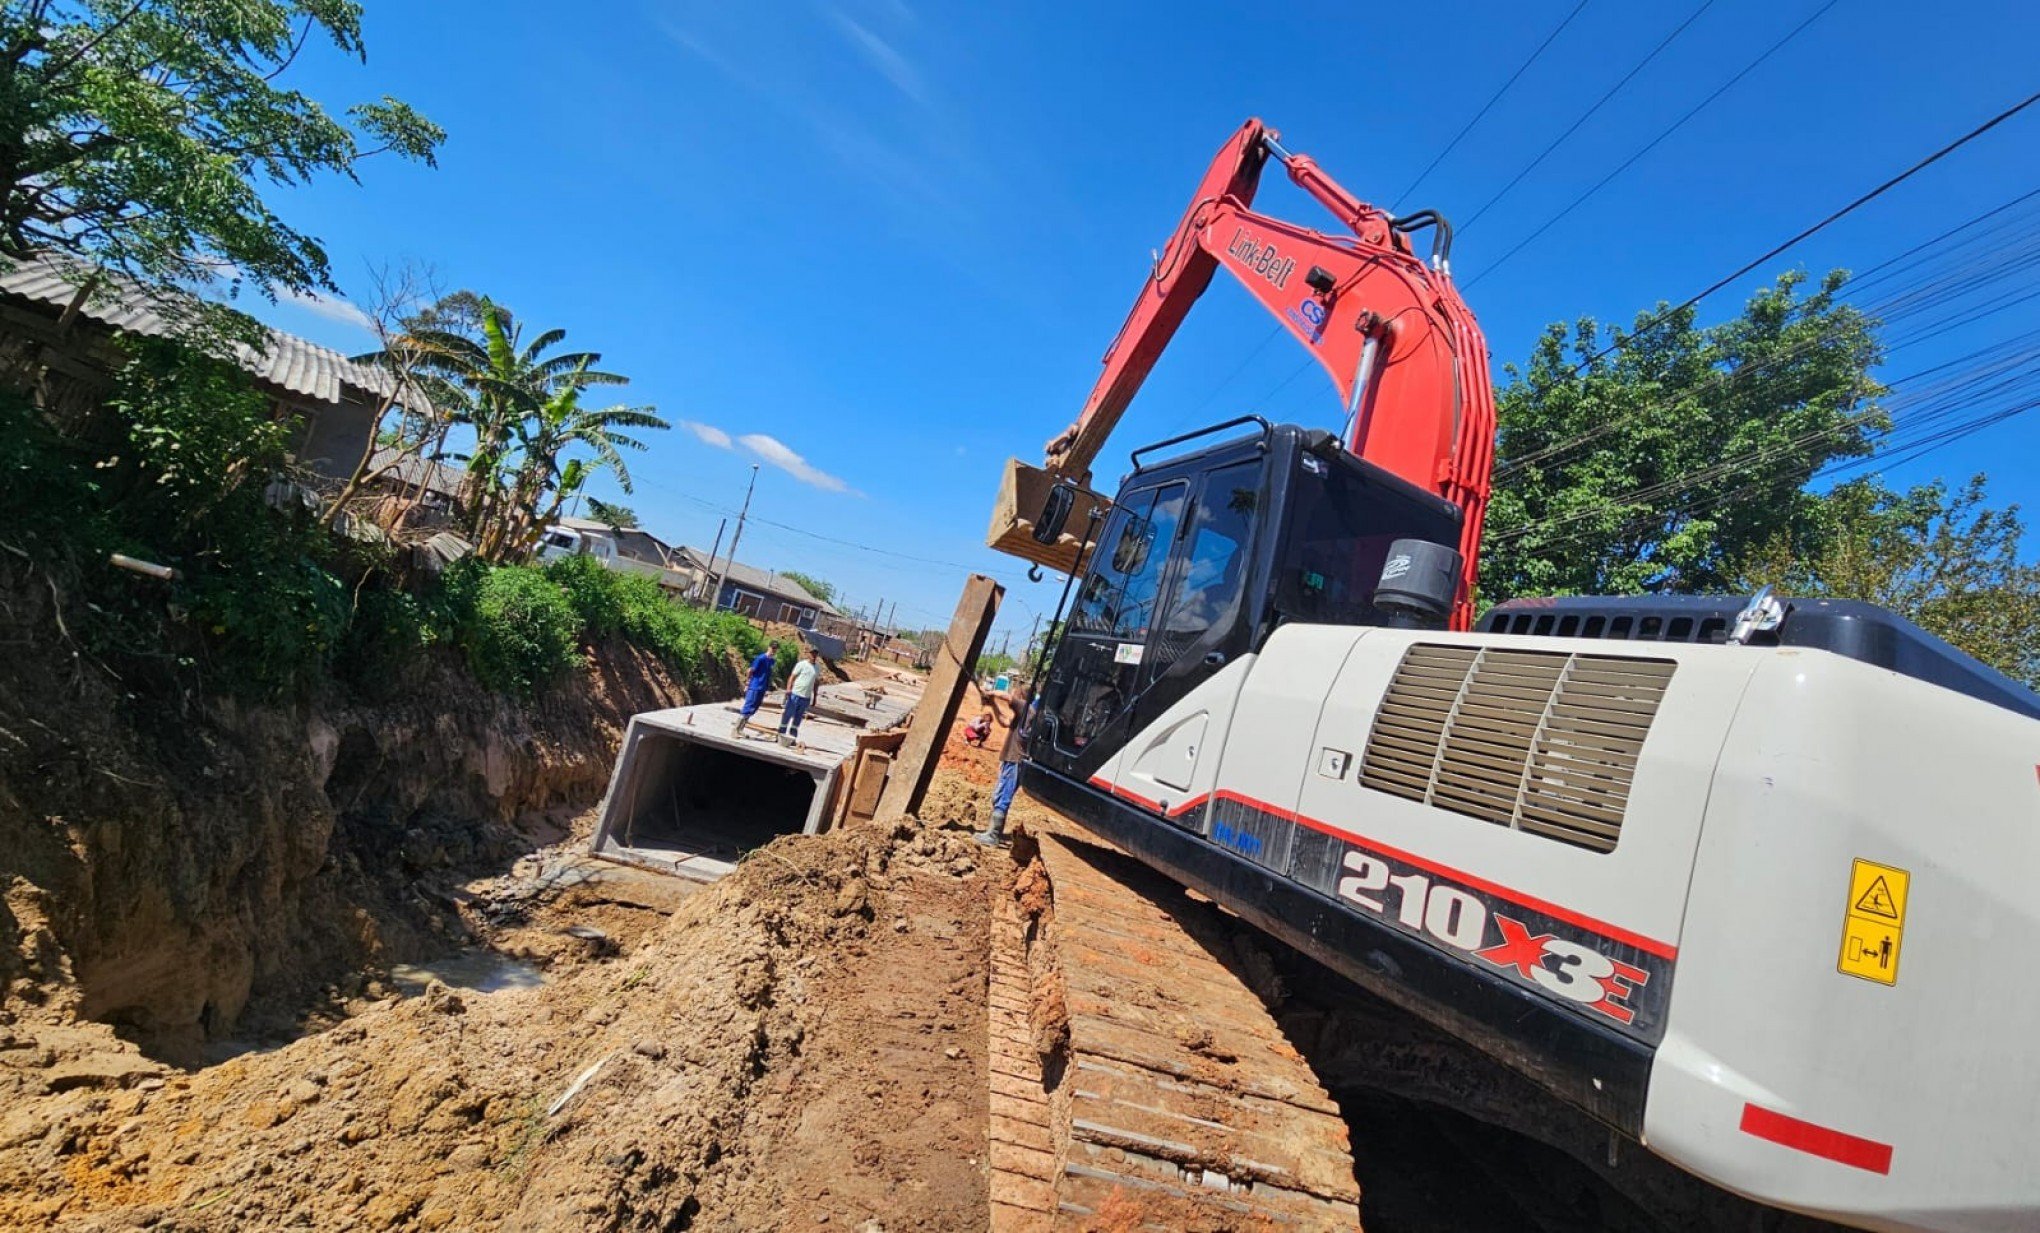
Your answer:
0,574 -> 718,1064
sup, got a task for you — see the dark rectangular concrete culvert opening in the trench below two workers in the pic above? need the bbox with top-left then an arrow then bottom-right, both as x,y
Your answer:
594,706 -> 843,880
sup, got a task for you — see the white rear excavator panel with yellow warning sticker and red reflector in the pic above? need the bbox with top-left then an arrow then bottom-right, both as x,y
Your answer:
1644,647 -> 2040,1229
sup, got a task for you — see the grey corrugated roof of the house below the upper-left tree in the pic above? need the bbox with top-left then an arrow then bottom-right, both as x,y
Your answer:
0,257 -> 392,402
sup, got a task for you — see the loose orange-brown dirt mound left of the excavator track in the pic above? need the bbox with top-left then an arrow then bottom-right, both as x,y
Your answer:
0,808 -> 987,1231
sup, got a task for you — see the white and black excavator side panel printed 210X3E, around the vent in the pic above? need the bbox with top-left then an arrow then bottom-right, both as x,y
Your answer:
1077,627 -> 1754,1133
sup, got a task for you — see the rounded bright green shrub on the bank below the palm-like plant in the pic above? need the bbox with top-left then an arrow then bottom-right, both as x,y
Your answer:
449,565 -> 581,694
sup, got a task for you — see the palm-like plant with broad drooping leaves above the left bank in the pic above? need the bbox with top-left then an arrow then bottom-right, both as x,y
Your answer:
387,292 -> 669,559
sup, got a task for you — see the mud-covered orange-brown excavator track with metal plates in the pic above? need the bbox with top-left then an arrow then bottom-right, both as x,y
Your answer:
989,812 -> 1361,1233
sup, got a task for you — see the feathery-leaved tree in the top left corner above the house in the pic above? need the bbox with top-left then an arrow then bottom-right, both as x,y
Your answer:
0,0 -> 445,294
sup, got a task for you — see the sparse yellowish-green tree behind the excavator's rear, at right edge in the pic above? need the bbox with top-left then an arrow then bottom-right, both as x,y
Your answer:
1736,476 -> 2040,688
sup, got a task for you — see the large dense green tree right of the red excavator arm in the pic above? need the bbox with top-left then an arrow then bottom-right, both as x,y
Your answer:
1481,272 -> 1889,602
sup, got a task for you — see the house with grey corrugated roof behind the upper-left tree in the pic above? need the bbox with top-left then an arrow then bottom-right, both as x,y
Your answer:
0,257 -> 410,480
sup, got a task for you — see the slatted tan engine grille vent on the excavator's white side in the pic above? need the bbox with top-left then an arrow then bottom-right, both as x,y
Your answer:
1361,643 -> 1677,851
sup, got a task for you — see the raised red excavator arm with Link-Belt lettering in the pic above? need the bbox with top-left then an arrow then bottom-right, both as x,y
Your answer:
987,120 -> 1495,629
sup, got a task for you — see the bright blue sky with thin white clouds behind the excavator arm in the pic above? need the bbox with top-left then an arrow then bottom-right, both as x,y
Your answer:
257,0 -> 2040,645
